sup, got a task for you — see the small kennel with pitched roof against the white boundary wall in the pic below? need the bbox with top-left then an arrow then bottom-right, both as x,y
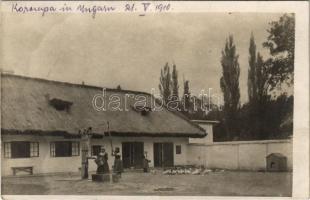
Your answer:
266,153 -> 287,172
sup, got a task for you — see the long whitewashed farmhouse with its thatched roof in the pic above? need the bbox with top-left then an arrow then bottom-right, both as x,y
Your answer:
1,74 -> 206,176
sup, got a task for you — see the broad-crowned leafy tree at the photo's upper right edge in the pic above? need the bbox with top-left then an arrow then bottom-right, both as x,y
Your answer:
263,14 -> 295,90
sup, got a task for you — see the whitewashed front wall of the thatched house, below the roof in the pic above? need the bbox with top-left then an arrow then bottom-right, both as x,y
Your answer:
1,135 -> 188,176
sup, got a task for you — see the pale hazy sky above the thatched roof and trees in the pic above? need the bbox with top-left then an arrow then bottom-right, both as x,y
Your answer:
1,13 -> 282,103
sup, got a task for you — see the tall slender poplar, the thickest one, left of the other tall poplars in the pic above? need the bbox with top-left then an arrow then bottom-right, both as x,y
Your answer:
220,35 -> 240,139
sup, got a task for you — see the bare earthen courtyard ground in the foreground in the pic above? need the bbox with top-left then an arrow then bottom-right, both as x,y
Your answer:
1,171 -> 292,196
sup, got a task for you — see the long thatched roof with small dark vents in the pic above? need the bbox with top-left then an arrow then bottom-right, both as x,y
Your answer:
1,74 -> 206,137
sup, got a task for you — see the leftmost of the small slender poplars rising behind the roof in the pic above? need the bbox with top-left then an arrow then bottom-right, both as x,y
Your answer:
158,63 -> 171,105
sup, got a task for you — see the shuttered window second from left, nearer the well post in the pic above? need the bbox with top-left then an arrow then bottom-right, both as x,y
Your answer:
50,141 -> 80,157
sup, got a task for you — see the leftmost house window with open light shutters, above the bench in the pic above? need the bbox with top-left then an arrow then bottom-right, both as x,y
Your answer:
4,141 -> 39,158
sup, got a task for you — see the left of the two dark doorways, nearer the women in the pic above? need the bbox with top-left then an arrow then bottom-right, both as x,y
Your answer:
122,142 -> 144,169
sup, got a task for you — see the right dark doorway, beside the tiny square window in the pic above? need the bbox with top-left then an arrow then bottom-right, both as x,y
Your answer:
154,142 -> 174,167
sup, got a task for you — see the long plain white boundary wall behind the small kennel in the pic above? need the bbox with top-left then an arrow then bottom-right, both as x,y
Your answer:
187,140 -> 293,171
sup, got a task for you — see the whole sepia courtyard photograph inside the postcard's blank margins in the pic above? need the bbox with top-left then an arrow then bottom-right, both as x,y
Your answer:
1,5 -> 295,197
